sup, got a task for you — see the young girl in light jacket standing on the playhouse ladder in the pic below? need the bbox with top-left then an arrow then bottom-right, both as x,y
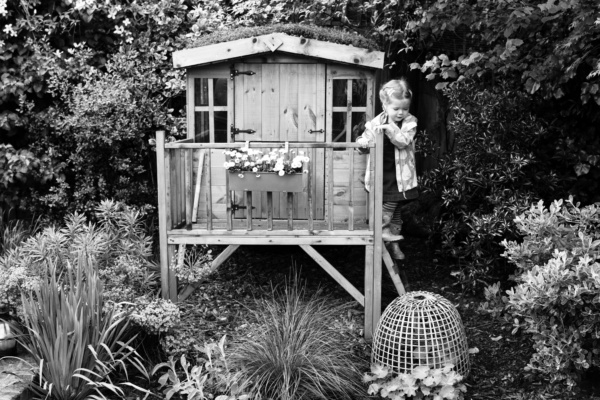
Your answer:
356,79 -> 419,260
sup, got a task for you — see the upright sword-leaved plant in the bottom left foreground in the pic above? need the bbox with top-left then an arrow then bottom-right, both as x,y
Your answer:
21,253 -> 149,400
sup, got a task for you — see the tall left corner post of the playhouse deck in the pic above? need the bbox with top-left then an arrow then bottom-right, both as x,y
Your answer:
156,131 -> 177,300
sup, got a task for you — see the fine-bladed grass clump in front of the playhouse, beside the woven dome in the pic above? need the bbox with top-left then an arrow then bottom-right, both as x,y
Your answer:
231,279 -> 366,400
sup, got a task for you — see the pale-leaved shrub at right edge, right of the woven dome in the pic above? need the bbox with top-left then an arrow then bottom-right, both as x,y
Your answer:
502,198 -> 600,387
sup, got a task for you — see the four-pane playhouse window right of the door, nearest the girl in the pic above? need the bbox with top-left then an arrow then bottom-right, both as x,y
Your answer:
332,79 -> 367,142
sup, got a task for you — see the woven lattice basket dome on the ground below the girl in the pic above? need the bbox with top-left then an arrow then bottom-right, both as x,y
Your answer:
371,292 -> 470,377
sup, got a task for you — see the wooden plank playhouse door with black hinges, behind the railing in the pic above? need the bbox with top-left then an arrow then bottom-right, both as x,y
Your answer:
232,64 -> 326,219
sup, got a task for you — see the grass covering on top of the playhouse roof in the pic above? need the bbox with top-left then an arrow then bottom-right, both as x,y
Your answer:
186,24 -> 380,50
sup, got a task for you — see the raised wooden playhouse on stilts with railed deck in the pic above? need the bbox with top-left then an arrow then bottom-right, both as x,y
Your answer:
156,28 -> 404,337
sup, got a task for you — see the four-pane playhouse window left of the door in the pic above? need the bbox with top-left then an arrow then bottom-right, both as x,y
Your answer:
193,78 -> 228,143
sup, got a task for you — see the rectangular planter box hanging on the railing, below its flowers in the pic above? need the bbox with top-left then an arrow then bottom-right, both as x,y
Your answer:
228,171 -> 307,192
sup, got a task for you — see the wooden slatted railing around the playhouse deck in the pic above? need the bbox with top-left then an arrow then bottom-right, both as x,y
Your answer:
156,132 -> 376,234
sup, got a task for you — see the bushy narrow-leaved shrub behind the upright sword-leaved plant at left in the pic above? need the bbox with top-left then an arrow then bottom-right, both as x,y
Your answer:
0,200 -> 179,340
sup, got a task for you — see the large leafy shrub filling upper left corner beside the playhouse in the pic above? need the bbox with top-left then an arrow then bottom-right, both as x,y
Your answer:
0,0 -> 197,221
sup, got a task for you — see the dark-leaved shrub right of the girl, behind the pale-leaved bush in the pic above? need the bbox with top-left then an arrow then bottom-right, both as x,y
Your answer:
423,83 -> 558,290
